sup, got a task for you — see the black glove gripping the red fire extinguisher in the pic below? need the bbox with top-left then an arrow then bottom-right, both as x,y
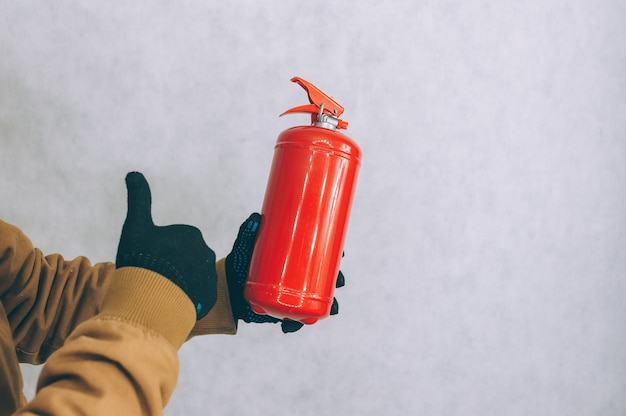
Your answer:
226,212 -> 345,334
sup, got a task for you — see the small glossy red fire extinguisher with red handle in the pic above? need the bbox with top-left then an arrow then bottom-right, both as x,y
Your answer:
244,77 -> 361,324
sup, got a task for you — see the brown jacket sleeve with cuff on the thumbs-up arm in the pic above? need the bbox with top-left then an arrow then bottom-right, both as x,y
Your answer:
16,267 -> 196,416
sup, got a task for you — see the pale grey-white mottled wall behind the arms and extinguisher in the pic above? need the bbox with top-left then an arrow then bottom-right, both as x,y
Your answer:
0,0 -> 626,416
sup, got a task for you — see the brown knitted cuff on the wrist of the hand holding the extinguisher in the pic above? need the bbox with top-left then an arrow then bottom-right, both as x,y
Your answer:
189,259 -> 237,338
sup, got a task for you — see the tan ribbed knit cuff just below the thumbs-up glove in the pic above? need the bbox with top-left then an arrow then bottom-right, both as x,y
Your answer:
98,267 -> 196,349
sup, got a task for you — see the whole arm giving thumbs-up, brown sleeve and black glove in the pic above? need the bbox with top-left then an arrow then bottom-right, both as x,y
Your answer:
18,173 -> 217,415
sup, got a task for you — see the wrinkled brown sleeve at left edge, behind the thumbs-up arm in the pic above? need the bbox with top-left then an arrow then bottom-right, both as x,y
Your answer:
0,220 -> 115,364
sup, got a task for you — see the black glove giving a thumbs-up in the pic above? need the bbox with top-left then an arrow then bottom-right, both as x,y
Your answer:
115,172 -> 217,319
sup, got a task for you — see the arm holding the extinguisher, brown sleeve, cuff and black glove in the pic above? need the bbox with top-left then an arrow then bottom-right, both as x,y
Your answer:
0,210 -> 336,364
